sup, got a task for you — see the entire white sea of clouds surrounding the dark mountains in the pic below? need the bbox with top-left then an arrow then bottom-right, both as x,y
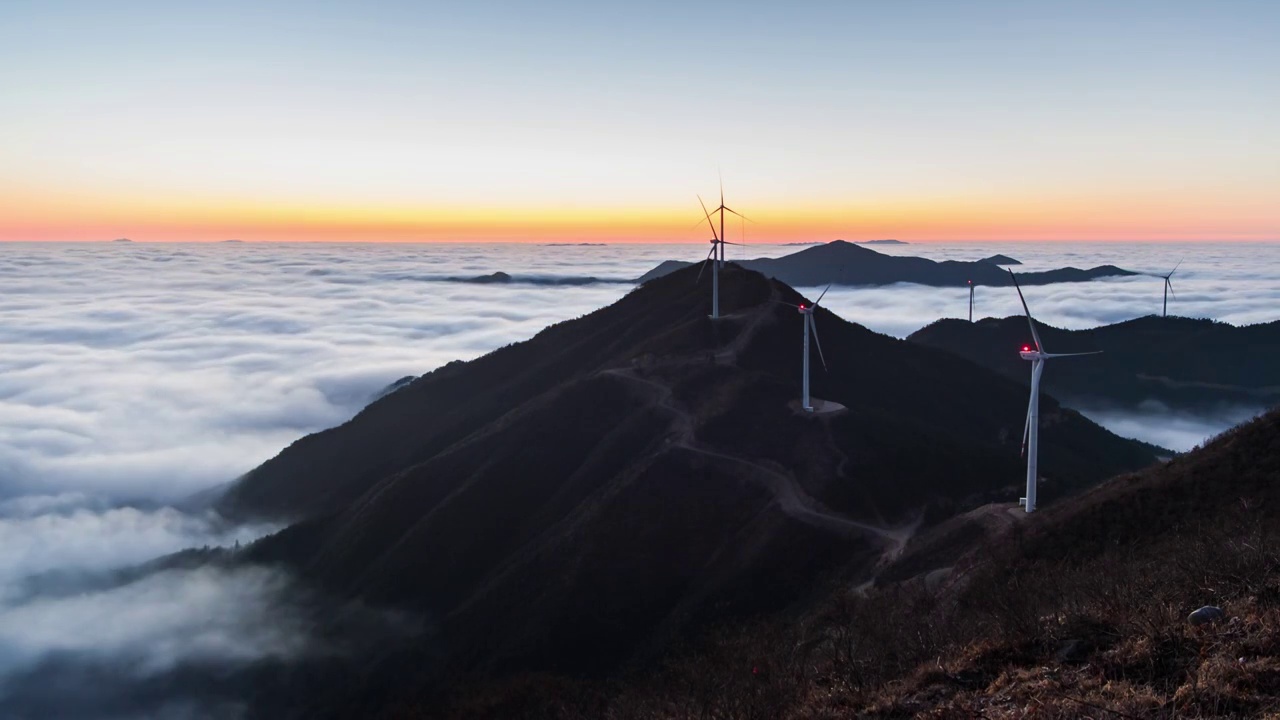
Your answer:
0,238 -> 1280,716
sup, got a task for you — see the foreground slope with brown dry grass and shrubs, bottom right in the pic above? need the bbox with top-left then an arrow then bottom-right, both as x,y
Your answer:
424,410 -> 1280,720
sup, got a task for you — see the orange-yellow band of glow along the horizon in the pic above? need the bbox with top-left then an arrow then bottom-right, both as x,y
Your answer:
0,185 -> 1280,243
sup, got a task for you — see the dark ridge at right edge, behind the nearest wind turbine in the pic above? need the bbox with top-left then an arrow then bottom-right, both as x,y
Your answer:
908,315 -> 1280,411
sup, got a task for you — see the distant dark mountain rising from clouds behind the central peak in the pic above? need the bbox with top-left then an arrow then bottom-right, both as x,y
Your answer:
639,240 -> 1137,287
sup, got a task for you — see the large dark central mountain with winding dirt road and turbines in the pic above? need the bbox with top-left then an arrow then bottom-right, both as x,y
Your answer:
220,265 -> 1153,712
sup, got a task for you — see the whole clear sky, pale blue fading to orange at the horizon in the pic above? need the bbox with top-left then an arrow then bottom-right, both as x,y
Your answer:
0,0 -> 1280,242
